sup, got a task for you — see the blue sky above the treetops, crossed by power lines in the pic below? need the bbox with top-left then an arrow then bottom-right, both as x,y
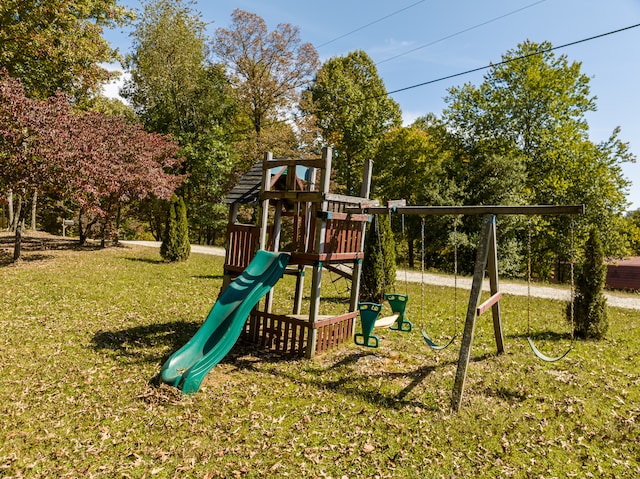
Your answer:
105,0 -> 640,210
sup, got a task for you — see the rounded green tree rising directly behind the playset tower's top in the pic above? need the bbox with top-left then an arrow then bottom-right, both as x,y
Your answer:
305,51 -> 401,194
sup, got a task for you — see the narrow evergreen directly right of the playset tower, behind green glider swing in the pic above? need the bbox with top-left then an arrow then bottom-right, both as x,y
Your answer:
360,215 -> 396,303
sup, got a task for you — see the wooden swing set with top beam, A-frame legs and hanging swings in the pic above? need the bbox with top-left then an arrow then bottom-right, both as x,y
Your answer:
347,205 -> 585,411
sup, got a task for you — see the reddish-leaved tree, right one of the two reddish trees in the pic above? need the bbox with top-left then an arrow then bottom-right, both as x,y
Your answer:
59,112 -> 184,245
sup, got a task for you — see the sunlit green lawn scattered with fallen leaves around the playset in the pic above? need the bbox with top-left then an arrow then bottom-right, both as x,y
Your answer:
0,242 -> 640,478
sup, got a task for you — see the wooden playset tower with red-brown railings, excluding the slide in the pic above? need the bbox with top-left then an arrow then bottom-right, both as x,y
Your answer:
224,148 -> 378,358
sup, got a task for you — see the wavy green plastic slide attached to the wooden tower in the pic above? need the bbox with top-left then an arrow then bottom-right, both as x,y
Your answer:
161,250 -> 289,394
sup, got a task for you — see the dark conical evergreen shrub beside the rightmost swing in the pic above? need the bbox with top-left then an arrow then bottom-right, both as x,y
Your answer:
567,228 -> 609,339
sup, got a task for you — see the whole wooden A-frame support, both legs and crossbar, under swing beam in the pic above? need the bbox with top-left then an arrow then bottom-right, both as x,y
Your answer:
451,215 -> 504,411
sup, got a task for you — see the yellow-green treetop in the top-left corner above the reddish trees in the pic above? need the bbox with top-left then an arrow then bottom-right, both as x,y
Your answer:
0,0 -> 132,100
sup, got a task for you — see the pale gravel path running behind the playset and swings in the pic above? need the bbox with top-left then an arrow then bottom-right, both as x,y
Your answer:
121,241 -> 640,311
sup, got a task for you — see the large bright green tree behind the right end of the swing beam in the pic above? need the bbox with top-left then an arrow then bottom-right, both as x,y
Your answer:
444,41 -> 634,273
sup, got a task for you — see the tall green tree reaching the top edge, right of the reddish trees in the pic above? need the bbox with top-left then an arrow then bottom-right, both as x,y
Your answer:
122,0 -> 236,246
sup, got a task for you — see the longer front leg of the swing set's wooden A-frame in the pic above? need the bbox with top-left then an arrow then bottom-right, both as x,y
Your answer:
451,214 -> 495,411
